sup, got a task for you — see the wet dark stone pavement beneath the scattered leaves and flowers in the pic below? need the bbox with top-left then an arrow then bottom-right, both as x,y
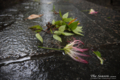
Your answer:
0,0 -> 120,80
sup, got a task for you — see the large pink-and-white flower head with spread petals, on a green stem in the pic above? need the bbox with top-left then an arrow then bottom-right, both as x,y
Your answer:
64,40 -> 88,63
